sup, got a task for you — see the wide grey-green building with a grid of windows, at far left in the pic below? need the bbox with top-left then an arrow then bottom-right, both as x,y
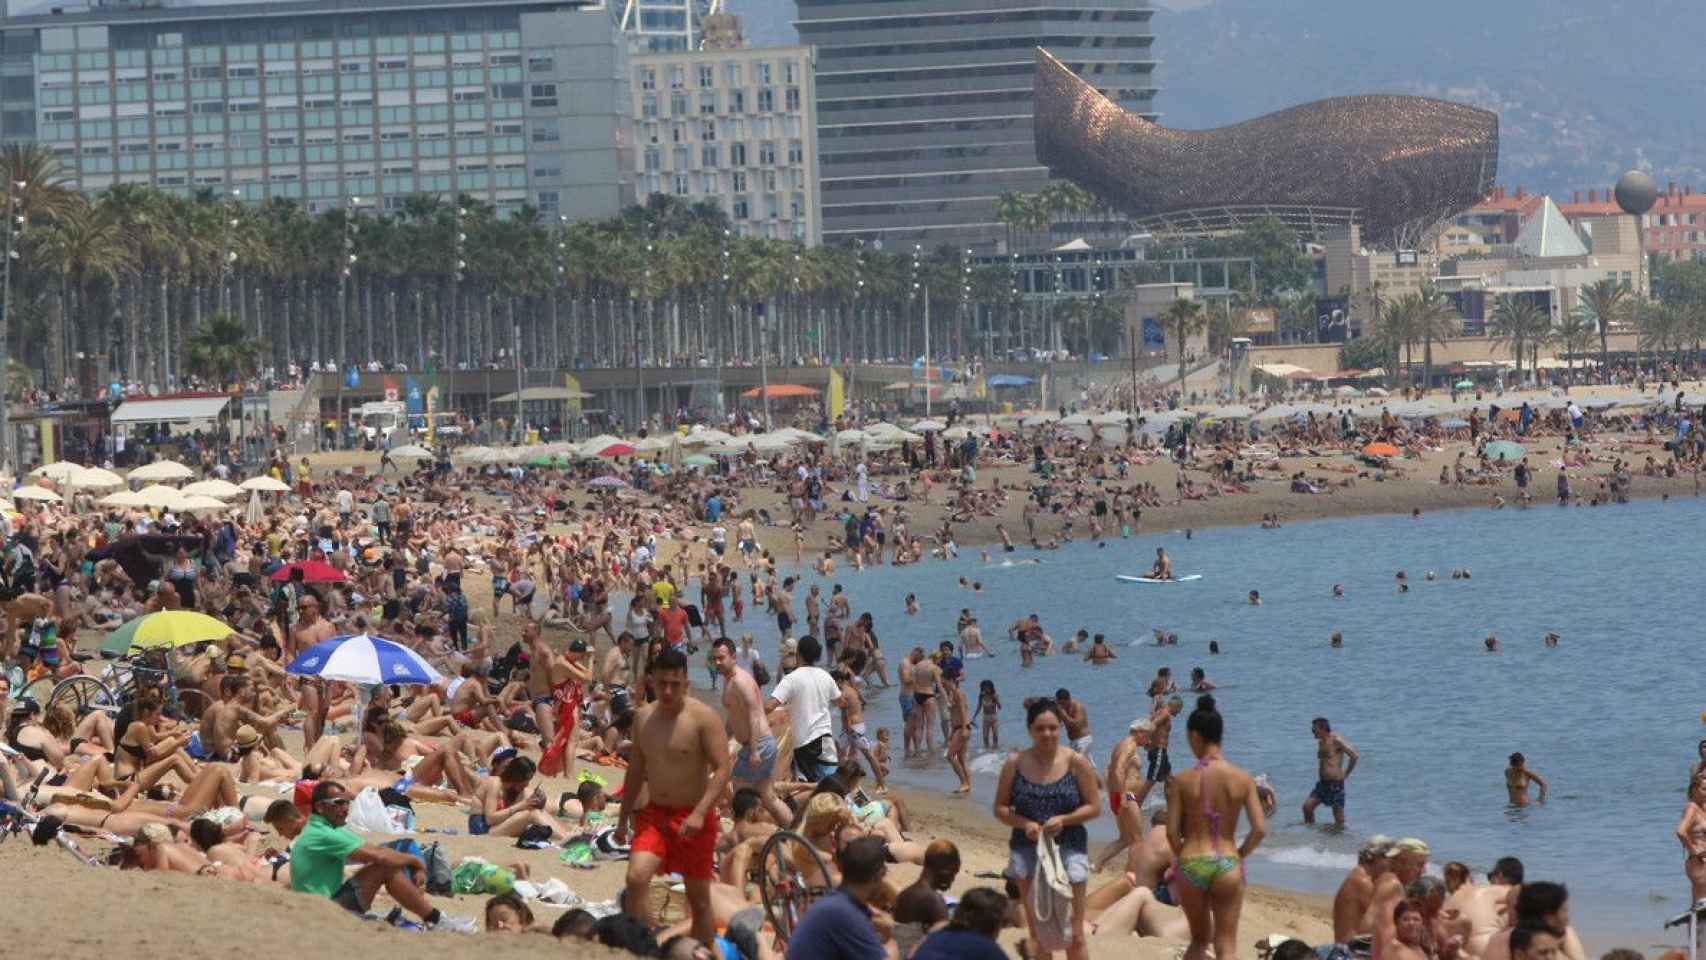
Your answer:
0,0 -> 633,218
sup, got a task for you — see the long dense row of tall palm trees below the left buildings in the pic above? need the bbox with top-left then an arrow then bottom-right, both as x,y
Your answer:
10,145 -> 1146,389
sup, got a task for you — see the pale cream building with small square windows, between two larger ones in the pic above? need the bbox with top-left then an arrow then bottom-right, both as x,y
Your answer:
631,46 -> 822,244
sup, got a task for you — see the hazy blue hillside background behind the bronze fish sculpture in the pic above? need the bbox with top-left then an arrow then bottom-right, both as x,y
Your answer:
725,0 -> 1706,196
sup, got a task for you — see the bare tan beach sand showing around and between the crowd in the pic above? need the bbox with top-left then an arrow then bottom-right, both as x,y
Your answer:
10,385 -> 1696,960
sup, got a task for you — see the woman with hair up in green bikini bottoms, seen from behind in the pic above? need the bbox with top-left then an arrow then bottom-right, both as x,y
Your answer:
1167,696 -> 1266,960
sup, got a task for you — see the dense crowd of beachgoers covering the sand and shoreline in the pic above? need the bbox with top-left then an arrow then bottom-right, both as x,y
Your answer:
0,383 -> 1706,960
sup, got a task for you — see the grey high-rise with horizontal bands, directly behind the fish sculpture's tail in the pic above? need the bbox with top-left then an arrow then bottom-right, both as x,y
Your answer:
795,0 -> 1155,249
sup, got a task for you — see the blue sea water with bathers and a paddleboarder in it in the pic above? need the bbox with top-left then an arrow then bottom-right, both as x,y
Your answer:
771,500 -> 1706,948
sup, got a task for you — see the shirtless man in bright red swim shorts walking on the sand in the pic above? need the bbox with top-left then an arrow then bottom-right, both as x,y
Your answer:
614,648 -> 730,943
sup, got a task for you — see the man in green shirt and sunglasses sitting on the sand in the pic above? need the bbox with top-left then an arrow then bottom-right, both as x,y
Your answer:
290,779 -> 474,933
